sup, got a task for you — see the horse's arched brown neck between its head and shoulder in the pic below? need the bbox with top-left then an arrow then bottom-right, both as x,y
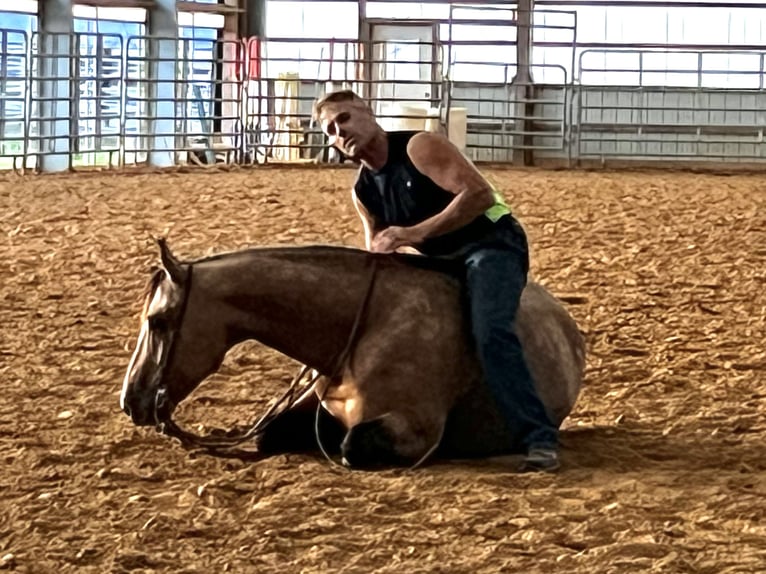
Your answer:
194,248 -> 371,374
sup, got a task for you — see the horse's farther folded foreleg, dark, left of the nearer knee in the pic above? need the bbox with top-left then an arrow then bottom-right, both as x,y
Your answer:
256,388 -> 346,454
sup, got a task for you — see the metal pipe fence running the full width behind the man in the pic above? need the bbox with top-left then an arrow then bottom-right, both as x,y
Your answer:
0,25 -> 766,169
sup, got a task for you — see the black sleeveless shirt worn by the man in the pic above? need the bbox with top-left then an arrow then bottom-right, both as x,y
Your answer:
354,131 -> 526,256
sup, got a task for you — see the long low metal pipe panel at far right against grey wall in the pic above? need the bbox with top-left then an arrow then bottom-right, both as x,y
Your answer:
575,86 -> 766,161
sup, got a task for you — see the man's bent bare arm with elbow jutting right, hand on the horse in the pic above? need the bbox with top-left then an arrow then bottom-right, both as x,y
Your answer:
372,132 -> 495,251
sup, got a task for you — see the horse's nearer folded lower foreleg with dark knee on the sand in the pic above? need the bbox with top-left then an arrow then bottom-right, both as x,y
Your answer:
341,412 -> 446,468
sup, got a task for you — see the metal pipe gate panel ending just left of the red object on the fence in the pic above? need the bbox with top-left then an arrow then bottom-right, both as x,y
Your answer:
123,35 -> 244,164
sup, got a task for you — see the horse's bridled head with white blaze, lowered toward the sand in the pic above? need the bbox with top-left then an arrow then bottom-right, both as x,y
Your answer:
120,239 -> 226,425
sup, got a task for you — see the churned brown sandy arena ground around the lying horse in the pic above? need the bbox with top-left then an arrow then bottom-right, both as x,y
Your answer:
0,164 -> 766,574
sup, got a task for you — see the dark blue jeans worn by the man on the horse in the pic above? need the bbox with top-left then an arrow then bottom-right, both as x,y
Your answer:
465,222 -> 558,450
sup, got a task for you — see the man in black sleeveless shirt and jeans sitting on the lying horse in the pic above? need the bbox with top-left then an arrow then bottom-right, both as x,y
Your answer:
314,90 -> 559,471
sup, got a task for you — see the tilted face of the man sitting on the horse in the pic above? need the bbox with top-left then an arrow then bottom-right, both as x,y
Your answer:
319,101 -> 380,160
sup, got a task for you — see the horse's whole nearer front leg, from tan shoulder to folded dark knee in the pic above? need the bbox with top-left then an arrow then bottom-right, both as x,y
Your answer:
339,292 -> 466,467
